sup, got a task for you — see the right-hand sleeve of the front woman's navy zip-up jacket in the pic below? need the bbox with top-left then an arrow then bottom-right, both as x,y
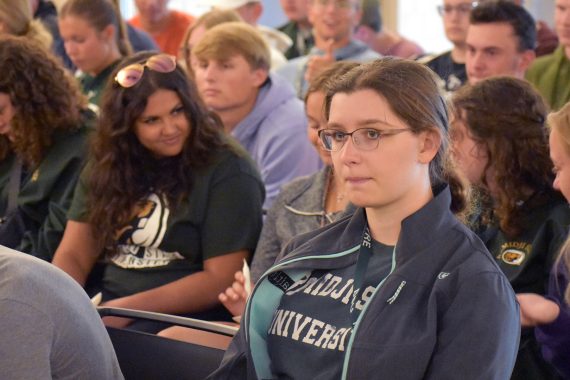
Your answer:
425,272 -> 520,380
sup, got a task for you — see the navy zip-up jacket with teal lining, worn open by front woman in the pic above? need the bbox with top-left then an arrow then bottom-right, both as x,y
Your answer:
211,186 -> 520,380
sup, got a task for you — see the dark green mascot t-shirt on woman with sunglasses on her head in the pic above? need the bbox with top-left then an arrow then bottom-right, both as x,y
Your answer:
68,142 -> 265,297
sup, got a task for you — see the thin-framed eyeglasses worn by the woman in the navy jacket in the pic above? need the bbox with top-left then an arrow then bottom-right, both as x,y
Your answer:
319,128 -> 410,152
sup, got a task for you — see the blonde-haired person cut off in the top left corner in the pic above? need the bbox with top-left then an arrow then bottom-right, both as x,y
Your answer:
0,0 -> 53,50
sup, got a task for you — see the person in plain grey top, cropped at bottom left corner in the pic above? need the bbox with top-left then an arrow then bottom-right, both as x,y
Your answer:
0,247 -> 123,380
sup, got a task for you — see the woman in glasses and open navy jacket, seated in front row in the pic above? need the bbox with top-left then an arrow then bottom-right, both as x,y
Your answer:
212,58 -> 519,379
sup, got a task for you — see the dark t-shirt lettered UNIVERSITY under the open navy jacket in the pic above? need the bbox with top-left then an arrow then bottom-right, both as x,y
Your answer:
267,241 -> 394,380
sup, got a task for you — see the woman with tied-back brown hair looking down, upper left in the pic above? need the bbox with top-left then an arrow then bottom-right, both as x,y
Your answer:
59,0 -> 131,110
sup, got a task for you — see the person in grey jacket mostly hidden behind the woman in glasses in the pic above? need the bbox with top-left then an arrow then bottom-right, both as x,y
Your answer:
160,62 -> 358,349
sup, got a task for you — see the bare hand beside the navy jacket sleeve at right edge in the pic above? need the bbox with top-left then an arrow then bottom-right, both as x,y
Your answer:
517,293 -> 560,327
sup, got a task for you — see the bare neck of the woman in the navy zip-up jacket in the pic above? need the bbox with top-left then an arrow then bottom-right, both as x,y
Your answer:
366,180 -> 433,245
